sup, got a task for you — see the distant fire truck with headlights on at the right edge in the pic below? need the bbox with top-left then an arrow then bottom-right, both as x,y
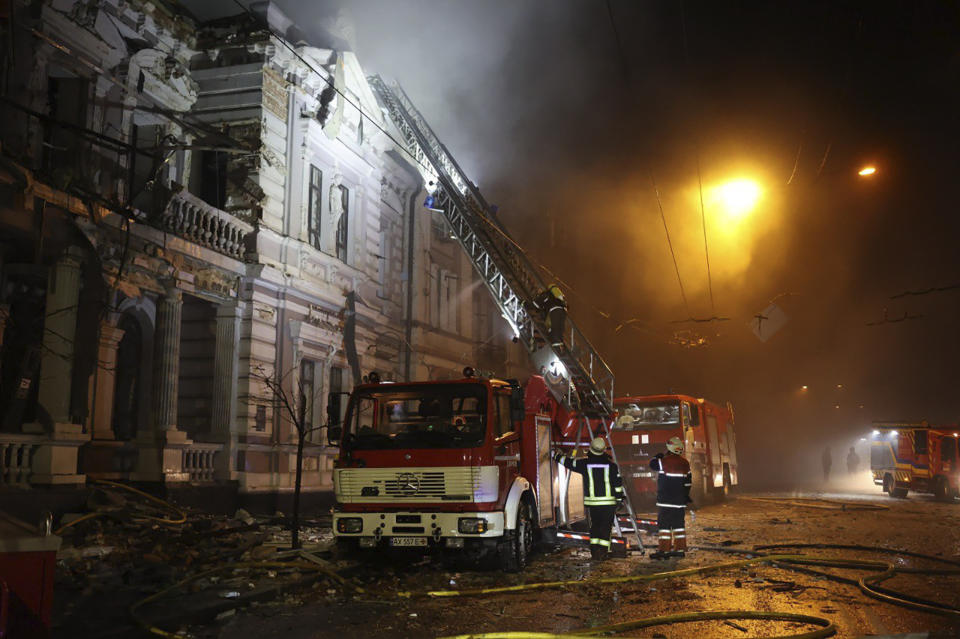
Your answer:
870,422 -> 960,499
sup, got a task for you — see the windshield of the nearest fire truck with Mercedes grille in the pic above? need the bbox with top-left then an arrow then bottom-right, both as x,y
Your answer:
346,384 -> 487,450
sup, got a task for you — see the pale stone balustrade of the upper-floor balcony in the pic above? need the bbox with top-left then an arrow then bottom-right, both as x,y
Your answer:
162,191 -> 253,260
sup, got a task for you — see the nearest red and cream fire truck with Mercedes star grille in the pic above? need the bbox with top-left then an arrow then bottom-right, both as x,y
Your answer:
330,370 -> 589,570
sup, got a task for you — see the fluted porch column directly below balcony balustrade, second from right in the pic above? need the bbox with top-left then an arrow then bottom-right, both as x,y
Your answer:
153,288 -> 183,433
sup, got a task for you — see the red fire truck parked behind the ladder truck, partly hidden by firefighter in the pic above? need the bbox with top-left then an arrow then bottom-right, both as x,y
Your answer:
610,395 -> 738,508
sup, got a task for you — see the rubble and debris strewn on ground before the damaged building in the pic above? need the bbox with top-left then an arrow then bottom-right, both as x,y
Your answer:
53,484 -> 349,637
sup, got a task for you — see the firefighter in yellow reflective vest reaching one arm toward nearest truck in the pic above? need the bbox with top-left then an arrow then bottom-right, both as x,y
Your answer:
554,437 -> 623,561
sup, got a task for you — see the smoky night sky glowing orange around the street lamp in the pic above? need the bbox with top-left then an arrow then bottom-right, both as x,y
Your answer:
185,0 -> 960,481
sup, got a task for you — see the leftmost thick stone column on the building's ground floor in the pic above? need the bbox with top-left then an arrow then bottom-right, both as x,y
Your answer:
39,247 -> 81,425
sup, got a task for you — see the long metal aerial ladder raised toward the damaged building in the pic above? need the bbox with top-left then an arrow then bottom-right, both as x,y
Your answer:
368,76 -> 643,550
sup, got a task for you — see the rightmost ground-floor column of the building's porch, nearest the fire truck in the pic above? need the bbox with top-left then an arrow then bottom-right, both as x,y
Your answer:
211,302 -> 243,479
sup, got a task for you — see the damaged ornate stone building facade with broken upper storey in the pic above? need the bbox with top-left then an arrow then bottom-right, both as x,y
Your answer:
0,0 -> 526,492
